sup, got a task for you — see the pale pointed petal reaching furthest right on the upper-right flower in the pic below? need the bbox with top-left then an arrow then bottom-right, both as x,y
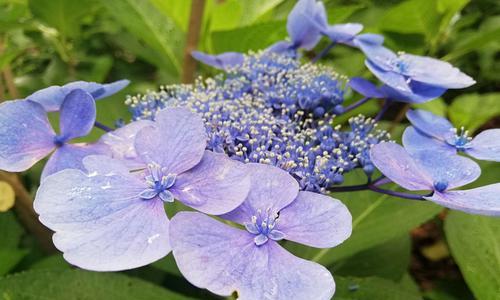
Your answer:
400,54 -> 476,89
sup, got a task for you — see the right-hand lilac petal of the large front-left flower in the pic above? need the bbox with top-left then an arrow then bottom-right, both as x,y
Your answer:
170,151 -> 250,215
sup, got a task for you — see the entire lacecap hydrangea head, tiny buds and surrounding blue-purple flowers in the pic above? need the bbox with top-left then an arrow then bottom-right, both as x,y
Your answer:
0,0 -> 500,299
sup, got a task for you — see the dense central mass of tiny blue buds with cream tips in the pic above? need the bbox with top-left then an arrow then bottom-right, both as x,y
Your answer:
126,52 -> 389,193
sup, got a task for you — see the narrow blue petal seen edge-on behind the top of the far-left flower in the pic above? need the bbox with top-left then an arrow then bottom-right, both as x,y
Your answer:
26,79 -> 130,111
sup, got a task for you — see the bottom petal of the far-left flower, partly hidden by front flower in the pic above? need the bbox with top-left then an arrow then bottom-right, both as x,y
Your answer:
42,144 -> 107,180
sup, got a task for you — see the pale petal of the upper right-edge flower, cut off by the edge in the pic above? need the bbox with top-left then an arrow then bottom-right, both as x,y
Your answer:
465,129 -> 500,161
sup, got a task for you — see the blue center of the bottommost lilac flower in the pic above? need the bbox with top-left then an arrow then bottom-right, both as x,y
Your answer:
245,208 -> 285,246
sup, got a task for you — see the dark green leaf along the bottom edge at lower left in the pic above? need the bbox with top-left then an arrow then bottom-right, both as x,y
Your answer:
0,270 -> 193,300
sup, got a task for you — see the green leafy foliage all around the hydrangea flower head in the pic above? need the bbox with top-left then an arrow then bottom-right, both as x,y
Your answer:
0,0 -> 500,300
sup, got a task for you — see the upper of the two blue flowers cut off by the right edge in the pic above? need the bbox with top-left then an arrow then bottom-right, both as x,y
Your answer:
403,110 -> 500,161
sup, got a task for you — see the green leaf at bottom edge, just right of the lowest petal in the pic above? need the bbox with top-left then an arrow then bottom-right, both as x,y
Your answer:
334,276 -> 422,300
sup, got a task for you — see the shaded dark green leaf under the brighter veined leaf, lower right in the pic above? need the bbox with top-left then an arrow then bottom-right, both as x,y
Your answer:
332,234 -> 411,281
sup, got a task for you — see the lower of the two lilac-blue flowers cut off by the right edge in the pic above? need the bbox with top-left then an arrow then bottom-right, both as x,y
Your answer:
371,143 -> 500,216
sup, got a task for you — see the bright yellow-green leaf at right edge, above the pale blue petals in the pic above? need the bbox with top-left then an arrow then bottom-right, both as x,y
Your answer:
449,93 -> 500,132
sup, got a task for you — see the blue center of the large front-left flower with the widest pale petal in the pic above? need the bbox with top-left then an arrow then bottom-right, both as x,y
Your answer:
139,163 -> 177,202
